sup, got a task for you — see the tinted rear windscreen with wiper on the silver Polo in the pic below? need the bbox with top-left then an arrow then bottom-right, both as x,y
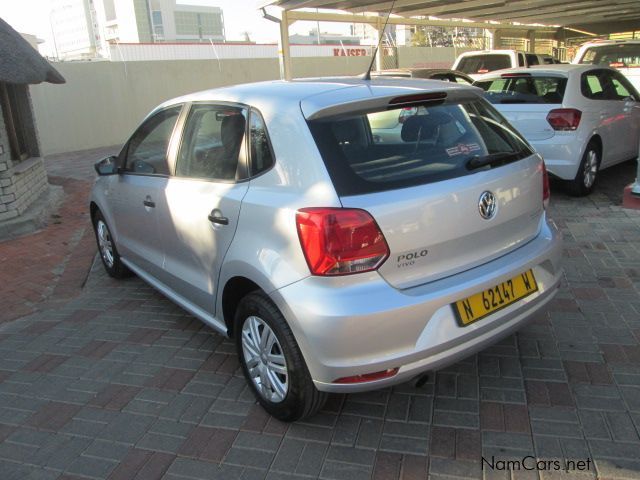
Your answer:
309,99 -> 532,195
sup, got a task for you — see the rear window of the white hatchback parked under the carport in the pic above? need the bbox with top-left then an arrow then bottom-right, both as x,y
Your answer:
473,76 -> 567,104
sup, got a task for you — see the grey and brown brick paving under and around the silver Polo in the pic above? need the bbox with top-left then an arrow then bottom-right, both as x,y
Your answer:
0,151 -> 640,480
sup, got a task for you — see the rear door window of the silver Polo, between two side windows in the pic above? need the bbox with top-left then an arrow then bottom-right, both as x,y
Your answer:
176,105 -> 247,181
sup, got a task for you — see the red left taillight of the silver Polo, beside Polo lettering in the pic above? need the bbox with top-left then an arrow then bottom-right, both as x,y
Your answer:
296,208 -> 389,276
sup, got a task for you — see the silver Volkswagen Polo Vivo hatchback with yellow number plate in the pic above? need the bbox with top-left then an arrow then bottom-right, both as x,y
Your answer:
90,78 -> 562,421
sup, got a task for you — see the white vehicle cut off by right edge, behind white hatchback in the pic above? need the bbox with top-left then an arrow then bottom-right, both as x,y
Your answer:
572,40 -> 640,90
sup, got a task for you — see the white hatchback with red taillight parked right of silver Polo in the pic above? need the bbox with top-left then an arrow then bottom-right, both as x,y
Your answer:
474,65 -> 640,196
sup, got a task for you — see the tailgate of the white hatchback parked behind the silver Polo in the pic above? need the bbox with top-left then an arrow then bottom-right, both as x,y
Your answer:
474,73 -> 567,142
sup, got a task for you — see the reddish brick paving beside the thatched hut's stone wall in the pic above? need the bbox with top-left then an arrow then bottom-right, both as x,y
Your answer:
0,148 -> 114,323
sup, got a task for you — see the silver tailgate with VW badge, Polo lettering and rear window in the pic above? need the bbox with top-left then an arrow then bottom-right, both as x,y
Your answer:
302,89 -> 543,289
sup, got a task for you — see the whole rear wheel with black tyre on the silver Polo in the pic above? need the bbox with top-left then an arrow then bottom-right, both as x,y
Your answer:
234,291 -> 327,422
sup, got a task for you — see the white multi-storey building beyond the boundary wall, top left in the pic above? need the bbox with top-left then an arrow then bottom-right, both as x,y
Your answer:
50,0 -> 225,60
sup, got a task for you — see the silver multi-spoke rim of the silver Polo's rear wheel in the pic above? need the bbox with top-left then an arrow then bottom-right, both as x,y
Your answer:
242,316 -> 289,403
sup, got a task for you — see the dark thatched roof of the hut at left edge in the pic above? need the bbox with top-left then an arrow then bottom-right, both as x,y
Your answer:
0,18 -> 65,84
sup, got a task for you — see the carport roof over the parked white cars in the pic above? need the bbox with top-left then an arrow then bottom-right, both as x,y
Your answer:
265,0 -> 640,31
